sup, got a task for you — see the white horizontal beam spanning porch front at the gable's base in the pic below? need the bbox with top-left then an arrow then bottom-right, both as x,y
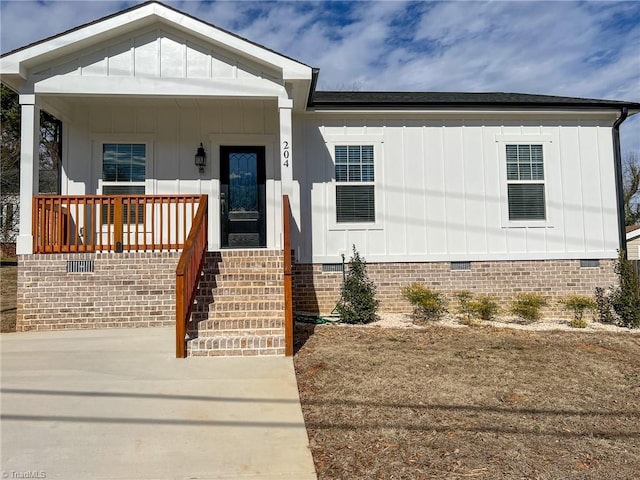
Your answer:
34,76 -> 287,98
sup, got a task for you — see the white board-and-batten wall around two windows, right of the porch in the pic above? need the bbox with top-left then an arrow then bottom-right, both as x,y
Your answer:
297,114 -> 618,263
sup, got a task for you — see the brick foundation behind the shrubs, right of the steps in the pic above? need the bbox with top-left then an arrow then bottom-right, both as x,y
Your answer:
293,260 -> 617,318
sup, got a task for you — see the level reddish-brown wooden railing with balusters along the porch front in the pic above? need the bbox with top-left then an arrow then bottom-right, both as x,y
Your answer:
32,195 -> 201,253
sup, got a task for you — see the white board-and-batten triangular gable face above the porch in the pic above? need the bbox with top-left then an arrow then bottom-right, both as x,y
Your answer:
31,25 -> 283,97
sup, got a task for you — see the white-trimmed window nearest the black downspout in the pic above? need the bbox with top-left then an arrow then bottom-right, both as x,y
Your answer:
496,134 -> 552,227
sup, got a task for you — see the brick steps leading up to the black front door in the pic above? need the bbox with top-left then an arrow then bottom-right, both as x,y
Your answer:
187,250 -> 285,356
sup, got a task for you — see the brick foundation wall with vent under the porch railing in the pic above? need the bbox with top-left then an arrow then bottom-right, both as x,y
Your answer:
16,252 -> 180,331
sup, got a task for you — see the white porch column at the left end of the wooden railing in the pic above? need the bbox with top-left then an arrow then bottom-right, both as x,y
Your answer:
16,95 -> 40,255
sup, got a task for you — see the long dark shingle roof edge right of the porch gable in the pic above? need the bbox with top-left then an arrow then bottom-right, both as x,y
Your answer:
309,91 -> 640,110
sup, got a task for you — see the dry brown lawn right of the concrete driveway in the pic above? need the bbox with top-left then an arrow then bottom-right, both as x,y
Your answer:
295,326 -> 640,480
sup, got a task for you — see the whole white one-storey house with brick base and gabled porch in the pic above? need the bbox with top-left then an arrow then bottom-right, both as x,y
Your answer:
0,2 -> 640,354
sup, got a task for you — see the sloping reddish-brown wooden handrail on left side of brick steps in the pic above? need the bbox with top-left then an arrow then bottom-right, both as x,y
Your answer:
176,195 -> 208,358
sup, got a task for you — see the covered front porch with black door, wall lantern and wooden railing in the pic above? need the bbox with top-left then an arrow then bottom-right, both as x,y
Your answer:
17,97 -> 299,255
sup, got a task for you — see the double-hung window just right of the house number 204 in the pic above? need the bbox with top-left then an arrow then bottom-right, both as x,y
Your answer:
334,145 -> 376,224
